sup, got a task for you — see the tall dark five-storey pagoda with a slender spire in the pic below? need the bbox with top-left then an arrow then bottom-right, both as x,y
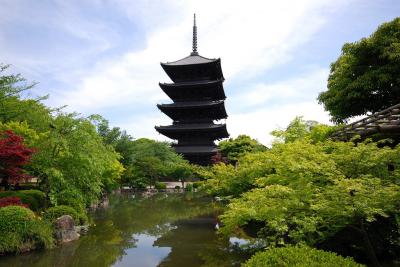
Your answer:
155,15 -> 229,165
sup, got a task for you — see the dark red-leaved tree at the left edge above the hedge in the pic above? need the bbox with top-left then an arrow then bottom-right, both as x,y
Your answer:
0,130 -> 35,188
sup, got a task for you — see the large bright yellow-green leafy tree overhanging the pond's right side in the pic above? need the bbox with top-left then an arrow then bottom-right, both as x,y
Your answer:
217,140 -> 400,264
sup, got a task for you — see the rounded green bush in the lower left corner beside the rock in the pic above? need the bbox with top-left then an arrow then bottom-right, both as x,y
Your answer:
0,206 -> 53,254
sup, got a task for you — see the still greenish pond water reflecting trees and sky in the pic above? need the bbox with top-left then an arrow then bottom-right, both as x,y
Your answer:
0,193 -> 247,267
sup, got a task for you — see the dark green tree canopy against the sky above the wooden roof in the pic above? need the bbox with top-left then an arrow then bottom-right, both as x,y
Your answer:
318,18 -> 400,122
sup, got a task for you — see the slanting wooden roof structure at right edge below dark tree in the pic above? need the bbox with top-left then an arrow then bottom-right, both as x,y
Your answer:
331,103 -> 400,141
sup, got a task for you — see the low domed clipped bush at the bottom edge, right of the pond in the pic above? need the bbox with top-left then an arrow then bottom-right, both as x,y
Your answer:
242,246 -> 364,267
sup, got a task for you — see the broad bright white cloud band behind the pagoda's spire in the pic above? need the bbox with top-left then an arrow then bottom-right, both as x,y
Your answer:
57,0 -> 350,112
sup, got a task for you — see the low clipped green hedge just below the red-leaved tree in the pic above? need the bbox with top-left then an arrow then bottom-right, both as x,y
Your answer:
0,190 -> 46,211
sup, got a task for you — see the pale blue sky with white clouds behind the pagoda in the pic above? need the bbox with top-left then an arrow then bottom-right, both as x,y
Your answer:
0,0 -> 400,145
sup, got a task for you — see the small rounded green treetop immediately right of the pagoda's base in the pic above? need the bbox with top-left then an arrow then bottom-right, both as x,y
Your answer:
218,135 -> 266,162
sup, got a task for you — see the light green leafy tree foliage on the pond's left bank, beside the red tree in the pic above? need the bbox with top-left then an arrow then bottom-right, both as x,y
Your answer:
0,65 -> 124,208
